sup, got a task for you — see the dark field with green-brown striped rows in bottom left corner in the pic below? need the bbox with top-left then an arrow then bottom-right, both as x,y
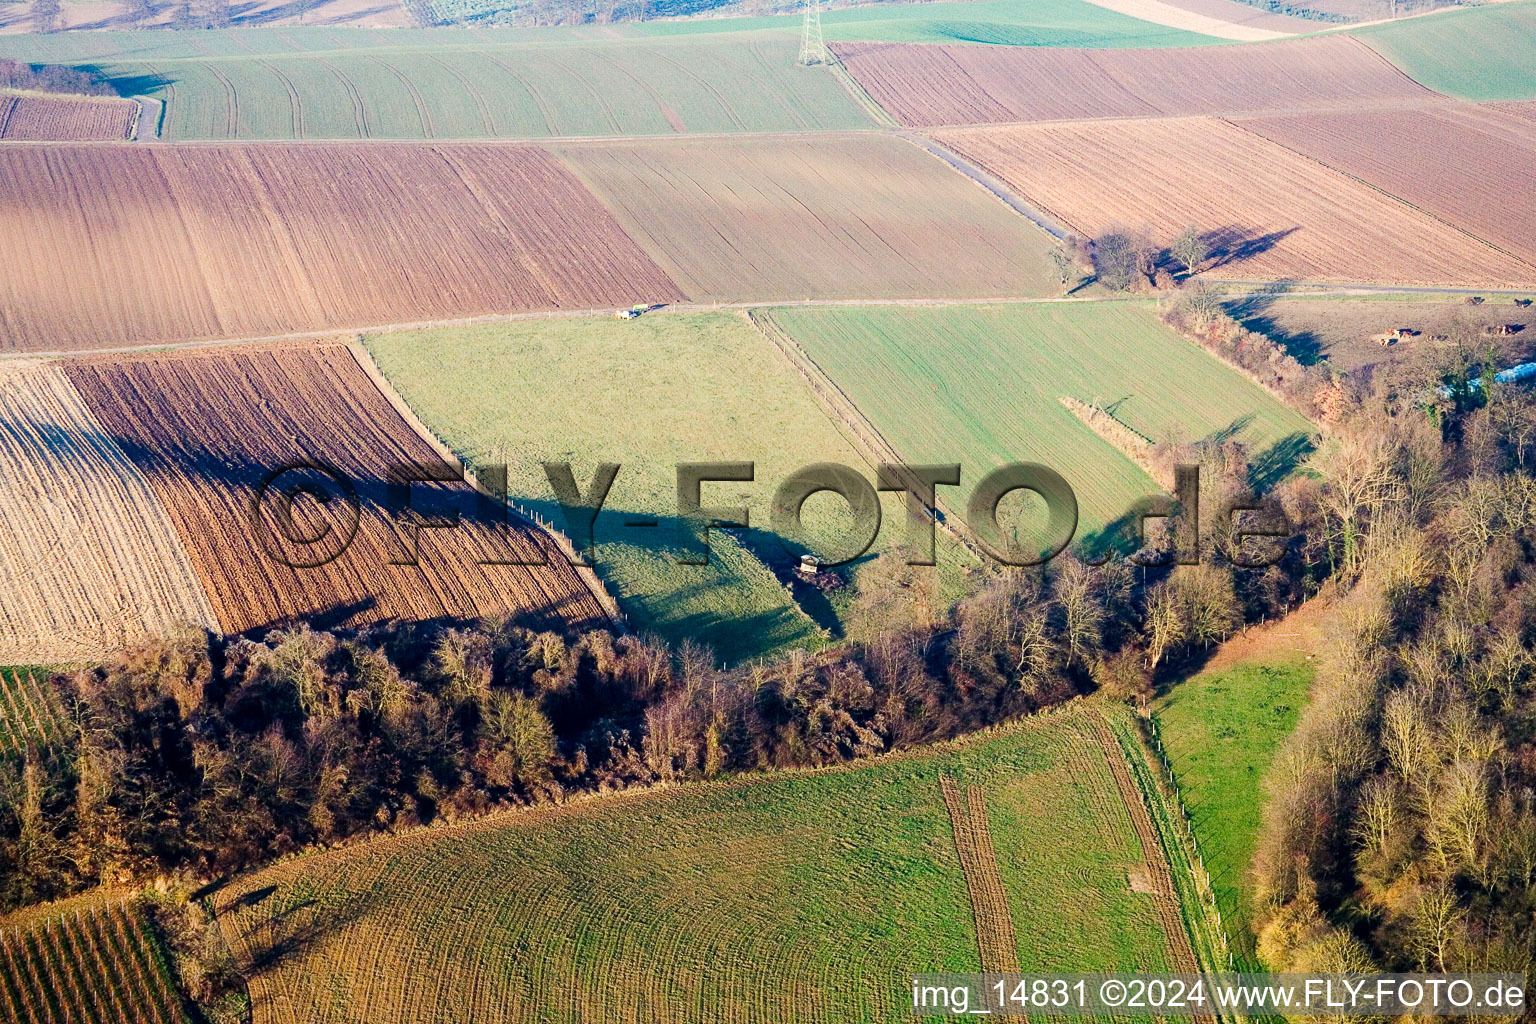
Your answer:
0,901 -> 187,1024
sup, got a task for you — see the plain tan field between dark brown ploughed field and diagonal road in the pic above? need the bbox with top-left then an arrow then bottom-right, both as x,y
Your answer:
558,135 -> 1052,302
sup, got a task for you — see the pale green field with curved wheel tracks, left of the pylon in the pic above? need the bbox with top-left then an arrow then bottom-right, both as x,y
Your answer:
89,32 -> 872,141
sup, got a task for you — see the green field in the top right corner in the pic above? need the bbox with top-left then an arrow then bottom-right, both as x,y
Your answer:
1355,0 -> 1536,100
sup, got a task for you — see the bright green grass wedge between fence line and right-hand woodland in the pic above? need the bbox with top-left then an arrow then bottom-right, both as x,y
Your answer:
1155,654 -> 1315,958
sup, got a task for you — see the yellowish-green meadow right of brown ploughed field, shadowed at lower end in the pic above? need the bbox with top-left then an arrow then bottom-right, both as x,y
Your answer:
367,313 -> 962,662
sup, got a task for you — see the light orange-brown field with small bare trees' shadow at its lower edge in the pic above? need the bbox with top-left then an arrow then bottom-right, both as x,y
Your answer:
935,118 -> 1536,287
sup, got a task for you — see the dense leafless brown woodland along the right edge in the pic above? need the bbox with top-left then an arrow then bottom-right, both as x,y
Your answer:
1253,334 -> 1536,973
